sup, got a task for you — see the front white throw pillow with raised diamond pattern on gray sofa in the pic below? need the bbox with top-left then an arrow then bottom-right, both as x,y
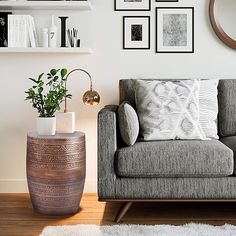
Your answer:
134,80 -> 206,140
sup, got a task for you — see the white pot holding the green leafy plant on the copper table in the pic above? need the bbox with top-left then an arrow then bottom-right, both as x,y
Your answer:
37,117 -> 56,135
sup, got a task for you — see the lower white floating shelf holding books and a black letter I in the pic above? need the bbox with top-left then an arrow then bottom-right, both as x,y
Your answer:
0,48 -> 93,54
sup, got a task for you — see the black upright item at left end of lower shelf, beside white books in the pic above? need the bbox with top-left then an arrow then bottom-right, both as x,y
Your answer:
0,12 -> 11,47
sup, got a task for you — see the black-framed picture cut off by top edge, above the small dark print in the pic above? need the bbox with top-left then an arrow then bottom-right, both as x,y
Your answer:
115,0 -> 151,11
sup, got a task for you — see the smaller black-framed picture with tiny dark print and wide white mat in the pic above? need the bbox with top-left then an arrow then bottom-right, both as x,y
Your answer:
123,16 -> 150,49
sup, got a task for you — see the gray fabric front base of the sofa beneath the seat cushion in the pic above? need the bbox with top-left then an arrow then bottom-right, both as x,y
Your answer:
115,177 -> 236,199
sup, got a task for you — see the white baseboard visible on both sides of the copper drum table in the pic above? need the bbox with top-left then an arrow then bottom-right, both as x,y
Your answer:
0,178 -> 97,193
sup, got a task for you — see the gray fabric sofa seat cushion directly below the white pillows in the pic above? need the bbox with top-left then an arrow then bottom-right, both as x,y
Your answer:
115,140 -> 234,178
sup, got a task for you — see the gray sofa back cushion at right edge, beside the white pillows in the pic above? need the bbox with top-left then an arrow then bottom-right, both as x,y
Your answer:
218,80 -> 236,137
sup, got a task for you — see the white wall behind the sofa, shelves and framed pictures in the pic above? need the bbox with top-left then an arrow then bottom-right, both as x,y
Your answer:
0,0 -> 236,192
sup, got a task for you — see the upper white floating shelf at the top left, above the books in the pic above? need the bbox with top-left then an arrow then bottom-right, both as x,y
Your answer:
0,1 -> 92,11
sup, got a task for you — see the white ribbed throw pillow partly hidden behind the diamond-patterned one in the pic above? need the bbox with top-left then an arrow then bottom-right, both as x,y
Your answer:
199,79 -> 219,139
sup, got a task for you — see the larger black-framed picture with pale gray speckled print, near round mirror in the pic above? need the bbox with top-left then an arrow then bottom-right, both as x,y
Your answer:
156,7 -> 194,53
